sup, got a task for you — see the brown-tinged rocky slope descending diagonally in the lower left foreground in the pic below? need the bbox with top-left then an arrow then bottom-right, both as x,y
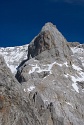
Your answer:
0,56 -> 39,125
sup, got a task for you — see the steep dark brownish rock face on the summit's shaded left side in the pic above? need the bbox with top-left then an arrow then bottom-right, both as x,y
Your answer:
28,31 -> 53,59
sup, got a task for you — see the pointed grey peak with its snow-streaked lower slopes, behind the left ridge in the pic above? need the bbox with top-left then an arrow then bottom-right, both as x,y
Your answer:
16,23 -> 84,125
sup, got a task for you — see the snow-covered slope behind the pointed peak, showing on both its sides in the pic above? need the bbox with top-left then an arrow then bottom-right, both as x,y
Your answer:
0,44 -> 84,74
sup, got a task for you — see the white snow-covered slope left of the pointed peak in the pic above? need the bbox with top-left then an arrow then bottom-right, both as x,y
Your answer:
0,44 -> 28,74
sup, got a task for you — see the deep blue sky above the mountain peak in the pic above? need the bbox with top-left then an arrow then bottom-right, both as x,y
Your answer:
0,0 -> 84,47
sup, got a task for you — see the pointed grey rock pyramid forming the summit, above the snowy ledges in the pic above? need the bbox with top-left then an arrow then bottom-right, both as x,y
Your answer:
28,23 -> 72,61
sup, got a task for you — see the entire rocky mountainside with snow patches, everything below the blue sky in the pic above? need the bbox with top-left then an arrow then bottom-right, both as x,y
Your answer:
0,23 -> 84,125
